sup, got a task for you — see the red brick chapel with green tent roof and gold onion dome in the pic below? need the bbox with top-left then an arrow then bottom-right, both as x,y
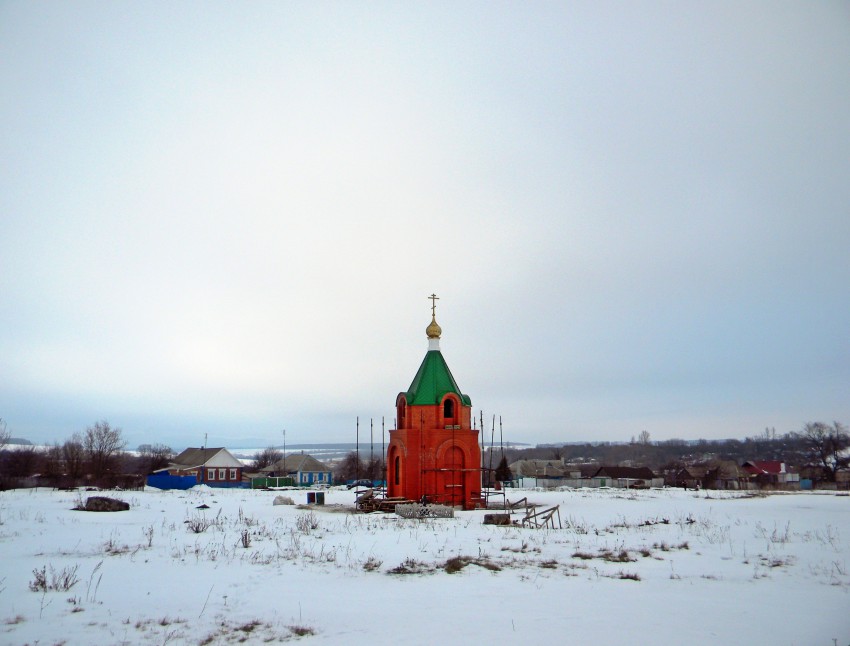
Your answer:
387,294 -> 481,509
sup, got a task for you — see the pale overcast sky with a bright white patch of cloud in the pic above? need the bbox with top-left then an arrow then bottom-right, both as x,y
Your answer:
0,0 -> 850,450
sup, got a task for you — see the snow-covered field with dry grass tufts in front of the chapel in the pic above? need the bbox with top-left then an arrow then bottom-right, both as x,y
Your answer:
0,487 -> 850,646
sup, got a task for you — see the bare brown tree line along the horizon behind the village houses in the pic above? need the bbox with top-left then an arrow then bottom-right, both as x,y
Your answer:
0,418 -> 850,489
